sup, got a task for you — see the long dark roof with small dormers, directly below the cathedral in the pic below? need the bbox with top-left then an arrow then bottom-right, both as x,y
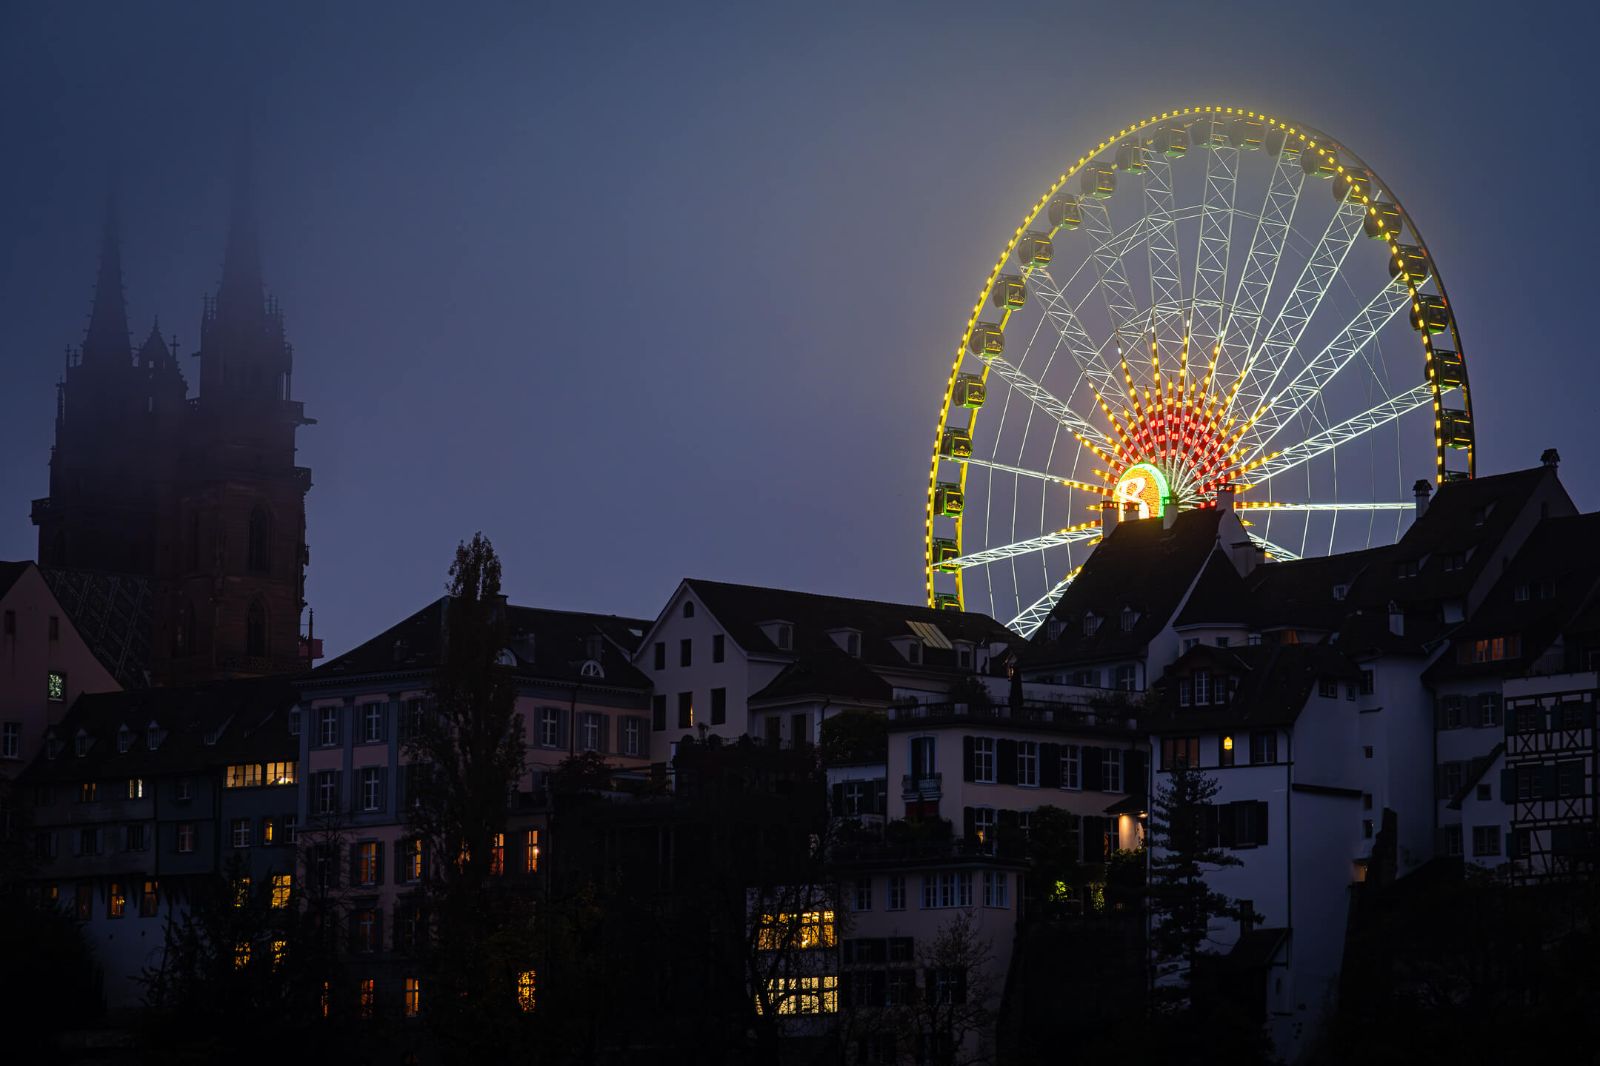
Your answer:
24,677 -> 299,781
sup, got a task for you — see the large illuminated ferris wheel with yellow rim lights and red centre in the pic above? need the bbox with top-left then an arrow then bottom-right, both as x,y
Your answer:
923,106 -> 1474,635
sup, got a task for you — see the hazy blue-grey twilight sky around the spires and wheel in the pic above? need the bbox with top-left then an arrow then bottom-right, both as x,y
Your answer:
0,0 -> 1600,653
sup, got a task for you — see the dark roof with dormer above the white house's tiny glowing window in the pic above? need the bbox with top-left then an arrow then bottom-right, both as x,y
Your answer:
1146,633 -> 1362,733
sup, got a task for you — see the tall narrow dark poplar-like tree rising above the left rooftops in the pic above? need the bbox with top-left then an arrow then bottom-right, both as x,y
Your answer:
406,533 -> 533,1061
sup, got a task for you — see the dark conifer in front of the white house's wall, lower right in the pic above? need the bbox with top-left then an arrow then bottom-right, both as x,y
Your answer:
1149,763 -> 1256,1010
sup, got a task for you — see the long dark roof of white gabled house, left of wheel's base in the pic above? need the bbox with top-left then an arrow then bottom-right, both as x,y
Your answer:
685,578 -> 1018,669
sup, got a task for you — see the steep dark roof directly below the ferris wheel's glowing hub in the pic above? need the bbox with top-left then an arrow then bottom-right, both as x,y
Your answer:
1027,509 -> 1221,666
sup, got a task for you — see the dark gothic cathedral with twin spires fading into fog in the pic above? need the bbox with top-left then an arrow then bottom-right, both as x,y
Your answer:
34,166 -> 310,683
